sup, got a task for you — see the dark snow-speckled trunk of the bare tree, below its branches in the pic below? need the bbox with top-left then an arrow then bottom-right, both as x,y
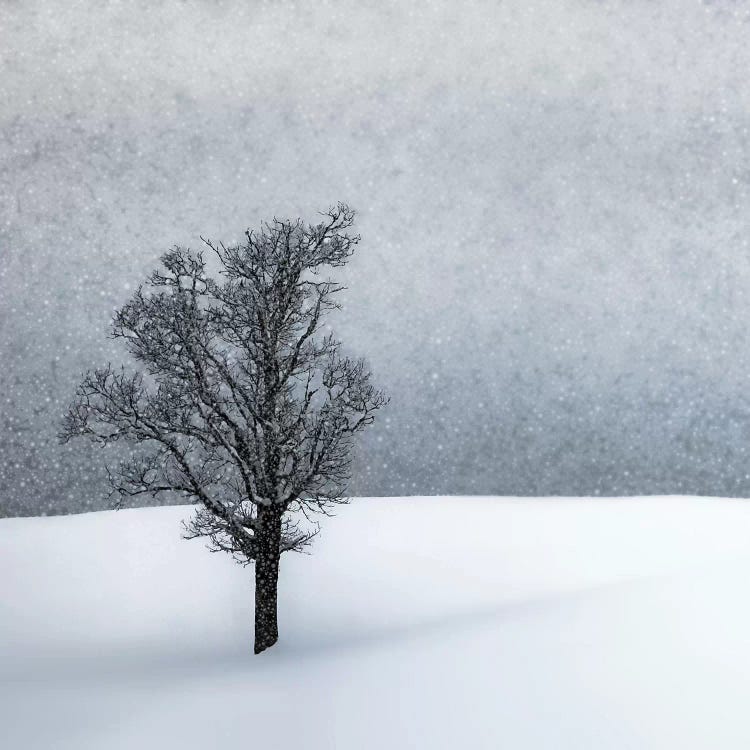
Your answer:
255,506 -> 282,654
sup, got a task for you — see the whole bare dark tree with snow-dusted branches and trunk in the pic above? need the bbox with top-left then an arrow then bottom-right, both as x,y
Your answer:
61,204 -> 387,653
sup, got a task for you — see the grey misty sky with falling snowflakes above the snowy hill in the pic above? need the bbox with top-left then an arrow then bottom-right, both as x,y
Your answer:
0,0 -> 750,515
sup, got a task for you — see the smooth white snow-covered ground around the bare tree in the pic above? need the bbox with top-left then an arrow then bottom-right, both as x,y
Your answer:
0,497 -> 750,750
